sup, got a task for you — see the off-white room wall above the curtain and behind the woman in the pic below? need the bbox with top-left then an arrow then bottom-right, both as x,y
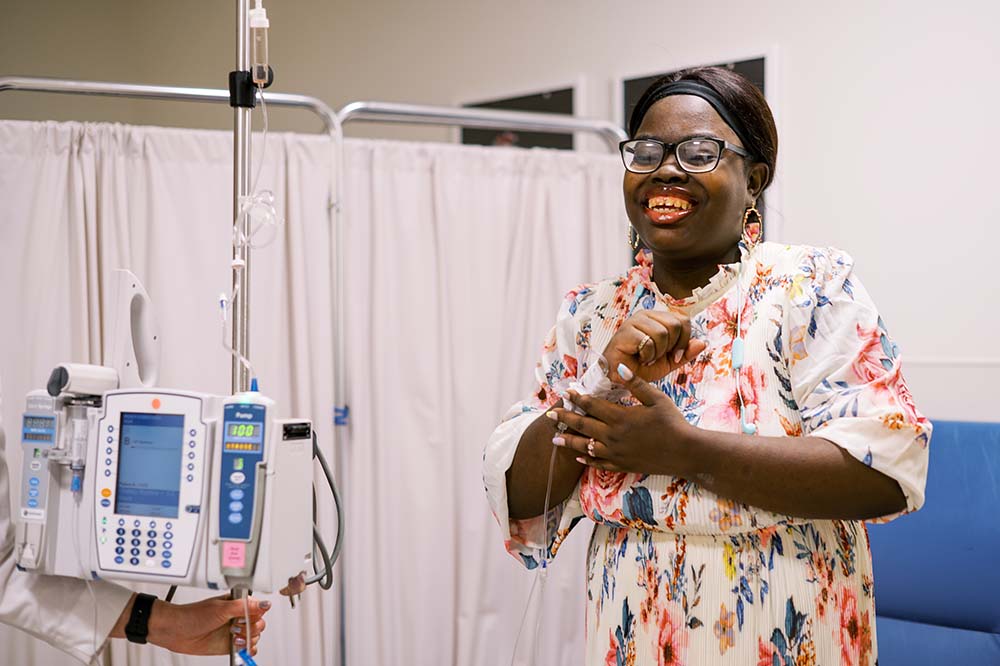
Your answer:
0,5 -> 1000,400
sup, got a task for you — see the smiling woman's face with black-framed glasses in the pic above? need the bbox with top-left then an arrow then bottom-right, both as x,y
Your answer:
623,95 -> 767,262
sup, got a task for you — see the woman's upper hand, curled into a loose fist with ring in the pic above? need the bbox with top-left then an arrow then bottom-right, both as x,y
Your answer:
604,310 -> 708,384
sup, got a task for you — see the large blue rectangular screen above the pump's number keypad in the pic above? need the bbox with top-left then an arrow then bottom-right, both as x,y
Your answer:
115,412 -> 184,518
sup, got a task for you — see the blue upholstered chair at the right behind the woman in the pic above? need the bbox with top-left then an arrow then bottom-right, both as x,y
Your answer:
869,421 -> 1000,666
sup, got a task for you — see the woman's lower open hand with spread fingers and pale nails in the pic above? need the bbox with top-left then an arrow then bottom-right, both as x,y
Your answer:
548,366 -> 694,476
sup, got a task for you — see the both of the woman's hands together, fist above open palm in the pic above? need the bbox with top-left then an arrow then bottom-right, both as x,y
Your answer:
546,310 -> 707,475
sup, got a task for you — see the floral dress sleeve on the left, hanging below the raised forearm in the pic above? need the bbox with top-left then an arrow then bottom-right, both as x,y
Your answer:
483,286 -> 597,569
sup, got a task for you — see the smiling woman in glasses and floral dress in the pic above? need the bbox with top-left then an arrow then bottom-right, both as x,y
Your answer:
485,68 -> 931,666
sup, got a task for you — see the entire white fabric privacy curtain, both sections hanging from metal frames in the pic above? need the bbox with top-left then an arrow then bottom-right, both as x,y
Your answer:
0,121 -> 628,666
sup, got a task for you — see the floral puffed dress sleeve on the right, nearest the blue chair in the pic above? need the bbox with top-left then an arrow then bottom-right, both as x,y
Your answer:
783,248 -> 931,521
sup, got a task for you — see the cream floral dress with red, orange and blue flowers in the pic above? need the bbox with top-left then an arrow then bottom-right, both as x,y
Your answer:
484,243 -> 931,666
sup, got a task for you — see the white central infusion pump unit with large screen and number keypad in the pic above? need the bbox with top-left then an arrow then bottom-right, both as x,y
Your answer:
91,390 -> 214,584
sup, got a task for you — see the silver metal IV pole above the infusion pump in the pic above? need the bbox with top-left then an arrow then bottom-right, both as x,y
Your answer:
232,0 -> 253,393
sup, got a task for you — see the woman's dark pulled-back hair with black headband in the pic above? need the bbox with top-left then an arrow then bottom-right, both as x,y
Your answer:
628,67 -> 778,188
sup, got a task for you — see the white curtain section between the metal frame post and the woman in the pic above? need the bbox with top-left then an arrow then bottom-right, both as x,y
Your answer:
343,142 -> 629,666
